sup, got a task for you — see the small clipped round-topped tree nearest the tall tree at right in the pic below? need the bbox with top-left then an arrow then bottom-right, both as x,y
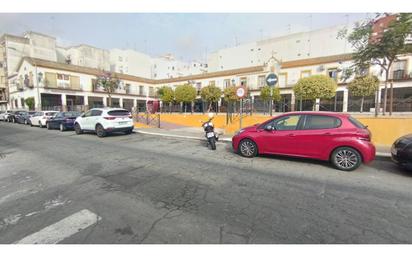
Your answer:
348,75 -> 379,112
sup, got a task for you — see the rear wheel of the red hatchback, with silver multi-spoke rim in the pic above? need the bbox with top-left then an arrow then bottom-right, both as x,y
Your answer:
331,147 -> 362,171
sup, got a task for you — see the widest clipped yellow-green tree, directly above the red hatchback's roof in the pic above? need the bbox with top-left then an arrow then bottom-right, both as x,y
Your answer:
293,75 -> 337,109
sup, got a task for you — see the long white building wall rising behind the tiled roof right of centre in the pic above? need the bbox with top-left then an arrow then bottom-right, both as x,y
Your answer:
208,26 -> 352,72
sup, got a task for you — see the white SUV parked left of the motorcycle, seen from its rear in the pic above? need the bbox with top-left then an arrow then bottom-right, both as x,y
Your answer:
74,108 -> 134,137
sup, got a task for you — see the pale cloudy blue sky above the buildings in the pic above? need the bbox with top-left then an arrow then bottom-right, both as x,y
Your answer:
0,13 -> 373,62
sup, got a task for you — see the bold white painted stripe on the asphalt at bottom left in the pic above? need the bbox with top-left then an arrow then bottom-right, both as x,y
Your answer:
14,209 -> 101,244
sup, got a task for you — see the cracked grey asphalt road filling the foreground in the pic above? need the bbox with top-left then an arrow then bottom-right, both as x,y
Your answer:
0,122 -> 412,244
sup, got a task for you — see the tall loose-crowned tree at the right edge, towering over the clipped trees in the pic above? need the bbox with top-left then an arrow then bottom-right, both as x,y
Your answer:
338,13 -> 412,115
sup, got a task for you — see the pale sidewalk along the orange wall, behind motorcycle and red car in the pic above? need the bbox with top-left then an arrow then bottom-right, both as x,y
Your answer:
135,126 -> 391,158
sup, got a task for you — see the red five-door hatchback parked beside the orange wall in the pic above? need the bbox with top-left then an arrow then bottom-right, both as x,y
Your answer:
232,112 -> 375,171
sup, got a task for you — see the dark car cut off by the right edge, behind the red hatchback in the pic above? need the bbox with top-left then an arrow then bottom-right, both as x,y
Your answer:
391,134 -> 412,170
